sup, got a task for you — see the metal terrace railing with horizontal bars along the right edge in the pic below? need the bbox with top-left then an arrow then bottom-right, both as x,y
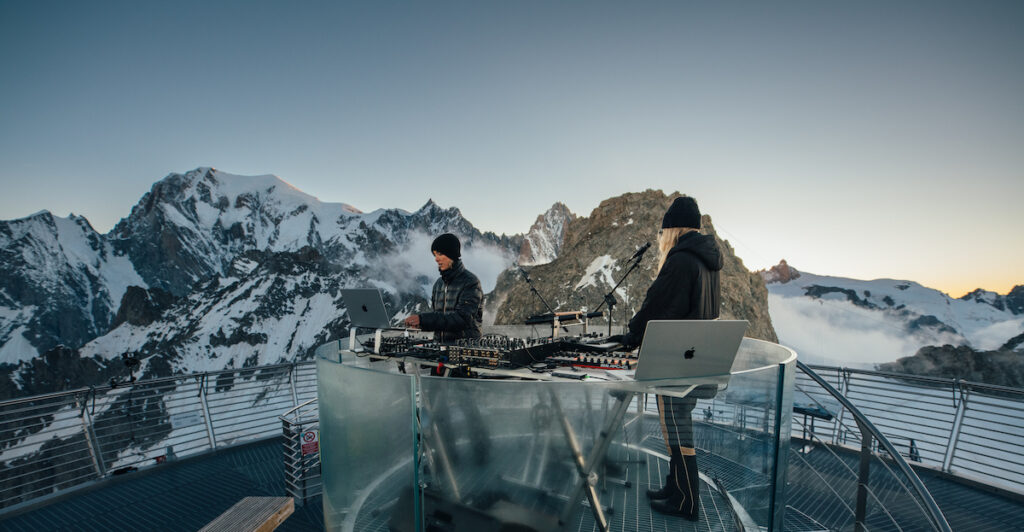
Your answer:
795,366 -> 1024,493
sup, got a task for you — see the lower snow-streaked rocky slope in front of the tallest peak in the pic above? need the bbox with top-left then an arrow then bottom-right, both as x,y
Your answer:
79,247 -> 350,376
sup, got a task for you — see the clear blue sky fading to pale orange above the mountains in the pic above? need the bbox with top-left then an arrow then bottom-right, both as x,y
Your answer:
0,0 -> 1024,297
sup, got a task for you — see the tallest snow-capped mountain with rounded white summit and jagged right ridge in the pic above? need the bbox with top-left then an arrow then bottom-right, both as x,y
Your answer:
111,168 -> 518,296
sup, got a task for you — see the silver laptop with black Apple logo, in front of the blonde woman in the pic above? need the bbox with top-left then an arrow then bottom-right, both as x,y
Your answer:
634,319 -> 748,381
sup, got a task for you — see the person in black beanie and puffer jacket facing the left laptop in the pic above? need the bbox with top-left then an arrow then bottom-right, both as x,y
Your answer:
406,233 -> 483,343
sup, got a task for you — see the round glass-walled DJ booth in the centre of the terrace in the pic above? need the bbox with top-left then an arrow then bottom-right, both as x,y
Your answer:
316,326 -> 796,531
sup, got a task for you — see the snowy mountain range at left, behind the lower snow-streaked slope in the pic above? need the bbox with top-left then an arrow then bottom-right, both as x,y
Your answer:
0,167 -> 521,390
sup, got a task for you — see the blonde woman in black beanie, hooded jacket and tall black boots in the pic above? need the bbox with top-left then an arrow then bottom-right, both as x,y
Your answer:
621,196 -> 723,521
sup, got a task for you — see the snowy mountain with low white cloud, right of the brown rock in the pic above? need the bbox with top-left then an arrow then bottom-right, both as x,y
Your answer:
761,261 -> 1024,367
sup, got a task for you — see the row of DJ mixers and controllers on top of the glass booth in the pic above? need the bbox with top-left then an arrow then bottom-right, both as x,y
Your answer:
367,334 -> 637,369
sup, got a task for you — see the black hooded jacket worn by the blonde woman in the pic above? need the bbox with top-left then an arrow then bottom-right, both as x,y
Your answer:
624,231 -> 724,346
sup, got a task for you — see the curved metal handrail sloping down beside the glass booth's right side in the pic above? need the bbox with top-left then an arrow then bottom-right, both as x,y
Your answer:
786,362 -> 950,532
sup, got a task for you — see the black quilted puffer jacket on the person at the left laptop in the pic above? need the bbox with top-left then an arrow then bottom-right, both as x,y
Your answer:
420,261 -> 483,342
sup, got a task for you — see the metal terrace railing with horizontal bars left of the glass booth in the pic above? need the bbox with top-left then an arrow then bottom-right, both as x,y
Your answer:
0,361 -> 316,514
